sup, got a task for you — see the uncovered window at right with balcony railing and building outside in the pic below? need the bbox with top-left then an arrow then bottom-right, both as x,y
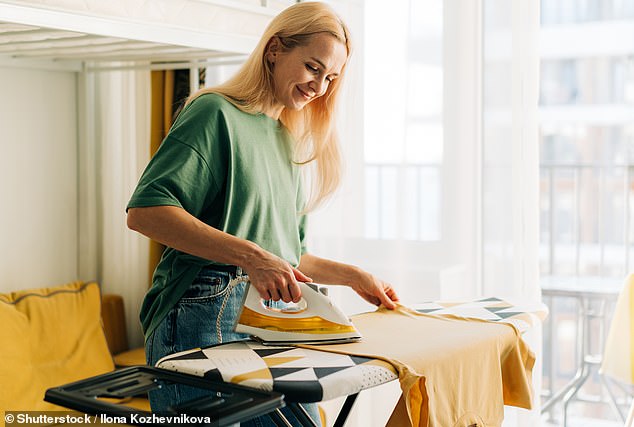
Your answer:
539,0 -> 634,420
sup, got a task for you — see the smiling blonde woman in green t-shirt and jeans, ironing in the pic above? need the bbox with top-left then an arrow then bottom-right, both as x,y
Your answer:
128,3 -> 398,423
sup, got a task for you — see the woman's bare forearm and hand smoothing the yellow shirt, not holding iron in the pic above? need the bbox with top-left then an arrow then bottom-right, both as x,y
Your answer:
298,253 -> 398,309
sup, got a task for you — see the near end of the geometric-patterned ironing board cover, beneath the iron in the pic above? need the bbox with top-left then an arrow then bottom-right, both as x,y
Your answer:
156,341 -> 398,403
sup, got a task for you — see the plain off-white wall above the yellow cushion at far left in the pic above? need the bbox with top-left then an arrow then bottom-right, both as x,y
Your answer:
0,68 -> 78,292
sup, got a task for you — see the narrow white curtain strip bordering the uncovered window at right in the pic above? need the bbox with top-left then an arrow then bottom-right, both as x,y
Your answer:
482,0 -> 542,426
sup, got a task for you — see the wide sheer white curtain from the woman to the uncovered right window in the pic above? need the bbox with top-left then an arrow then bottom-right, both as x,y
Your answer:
309,0 -> 541,426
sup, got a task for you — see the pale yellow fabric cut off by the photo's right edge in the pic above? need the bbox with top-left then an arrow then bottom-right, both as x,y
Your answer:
600,275 -> 634,384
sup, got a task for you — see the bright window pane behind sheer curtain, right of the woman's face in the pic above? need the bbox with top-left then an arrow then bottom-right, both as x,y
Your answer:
364,0 -> 443,241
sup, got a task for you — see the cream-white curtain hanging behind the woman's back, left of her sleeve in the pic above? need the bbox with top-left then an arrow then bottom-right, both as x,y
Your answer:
80,66 -> 151,347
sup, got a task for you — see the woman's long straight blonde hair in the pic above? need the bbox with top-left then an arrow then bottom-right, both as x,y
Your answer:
188,2 -> 351,211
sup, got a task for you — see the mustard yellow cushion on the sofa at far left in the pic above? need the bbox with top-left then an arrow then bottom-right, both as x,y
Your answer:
0,282 -> 114,410
